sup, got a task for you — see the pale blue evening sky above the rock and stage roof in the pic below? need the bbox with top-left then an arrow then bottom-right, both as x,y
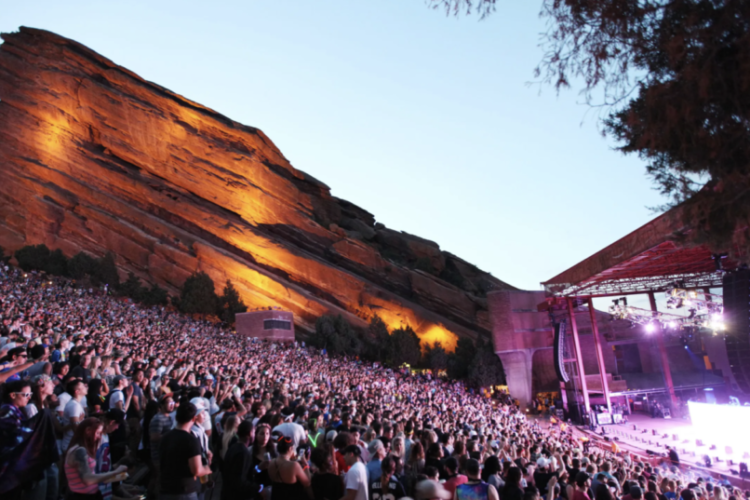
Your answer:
0,0 -> 663,290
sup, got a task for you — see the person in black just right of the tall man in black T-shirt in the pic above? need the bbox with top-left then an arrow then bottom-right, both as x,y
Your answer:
221,420 -> 258,500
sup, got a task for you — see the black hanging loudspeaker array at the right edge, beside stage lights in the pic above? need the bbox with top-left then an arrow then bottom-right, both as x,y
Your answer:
723,269 -> 750,394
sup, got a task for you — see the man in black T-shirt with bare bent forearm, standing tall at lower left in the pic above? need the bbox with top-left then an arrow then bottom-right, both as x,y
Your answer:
159,403 -> 211,500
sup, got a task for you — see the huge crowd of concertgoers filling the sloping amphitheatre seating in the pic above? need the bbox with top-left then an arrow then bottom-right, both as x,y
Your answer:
0,267 -> 748,500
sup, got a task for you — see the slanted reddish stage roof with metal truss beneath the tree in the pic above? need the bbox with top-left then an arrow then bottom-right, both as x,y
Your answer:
542,202 -> 737,297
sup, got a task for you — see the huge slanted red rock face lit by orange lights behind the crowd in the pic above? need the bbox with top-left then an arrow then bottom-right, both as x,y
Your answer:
0,28 -> 512,348
